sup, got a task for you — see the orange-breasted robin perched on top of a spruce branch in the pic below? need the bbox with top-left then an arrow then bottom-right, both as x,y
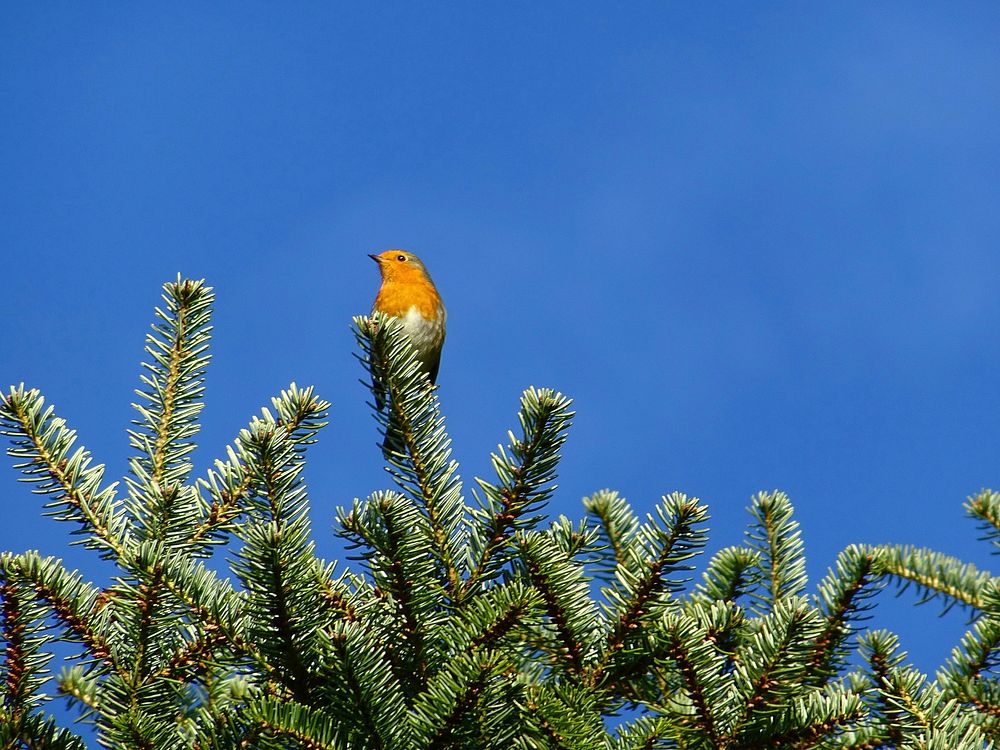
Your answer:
368,250 -> 448,457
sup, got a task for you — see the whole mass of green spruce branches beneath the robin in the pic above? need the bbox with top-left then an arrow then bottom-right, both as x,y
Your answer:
0,279 -> 1000,750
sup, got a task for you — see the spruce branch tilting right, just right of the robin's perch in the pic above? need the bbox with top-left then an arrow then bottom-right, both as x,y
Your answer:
460,388 -> 573,598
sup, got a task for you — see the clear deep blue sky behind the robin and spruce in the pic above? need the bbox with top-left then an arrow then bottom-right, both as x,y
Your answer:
0,2 -> 1000,712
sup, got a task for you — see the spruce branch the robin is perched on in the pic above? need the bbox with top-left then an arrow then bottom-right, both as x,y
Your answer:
354,313 -> 466,595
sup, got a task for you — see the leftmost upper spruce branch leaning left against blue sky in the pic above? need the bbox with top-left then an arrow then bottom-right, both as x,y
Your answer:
0,383 -> 129,558
